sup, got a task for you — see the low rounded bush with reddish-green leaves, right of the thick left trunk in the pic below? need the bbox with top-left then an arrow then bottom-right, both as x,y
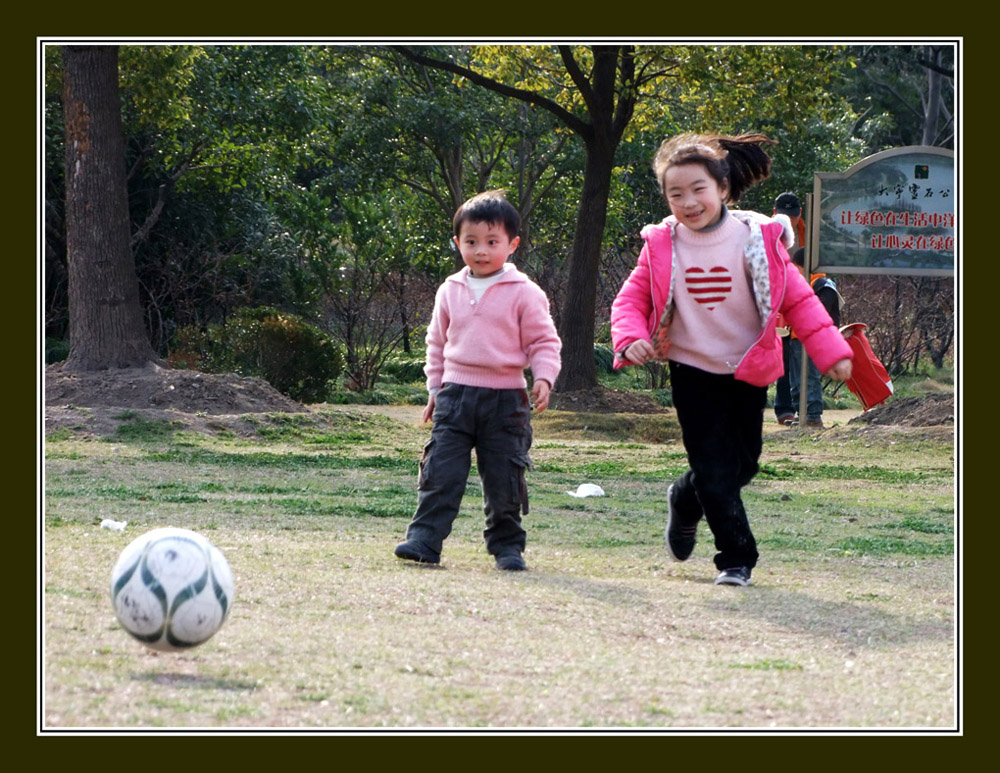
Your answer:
173,306 -> 343,403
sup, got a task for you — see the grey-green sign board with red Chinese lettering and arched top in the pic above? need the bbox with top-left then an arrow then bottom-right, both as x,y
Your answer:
810,145 -> 956,276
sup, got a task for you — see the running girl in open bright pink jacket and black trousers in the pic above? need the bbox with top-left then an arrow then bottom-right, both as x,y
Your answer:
611,134 -> 851,586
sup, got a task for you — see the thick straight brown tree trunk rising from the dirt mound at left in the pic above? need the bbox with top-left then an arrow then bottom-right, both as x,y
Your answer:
63,46 -> 157,371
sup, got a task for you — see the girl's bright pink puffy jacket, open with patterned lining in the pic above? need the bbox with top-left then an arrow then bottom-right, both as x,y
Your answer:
611,210 -> 852,386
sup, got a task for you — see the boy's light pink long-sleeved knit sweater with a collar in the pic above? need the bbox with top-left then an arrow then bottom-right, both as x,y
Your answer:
424,263 -> 562,389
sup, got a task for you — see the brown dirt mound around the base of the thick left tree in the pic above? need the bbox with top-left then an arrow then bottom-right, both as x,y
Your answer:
45,364 -> 305,415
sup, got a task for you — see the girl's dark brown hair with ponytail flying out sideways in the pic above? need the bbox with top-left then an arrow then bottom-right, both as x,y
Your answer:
653,134 -> 777,204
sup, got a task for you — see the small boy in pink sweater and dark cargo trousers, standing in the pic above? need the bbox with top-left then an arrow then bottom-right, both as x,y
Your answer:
395,191 -> 562,571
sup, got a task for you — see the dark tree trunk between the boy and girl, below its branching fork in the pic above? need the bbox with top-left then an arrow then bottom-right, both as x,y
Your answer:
557,140 -> 615,392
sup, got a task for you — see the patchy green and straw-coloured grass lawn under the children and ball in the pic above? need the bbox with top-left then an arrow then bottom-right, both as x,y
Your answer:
41,406 -> 957,732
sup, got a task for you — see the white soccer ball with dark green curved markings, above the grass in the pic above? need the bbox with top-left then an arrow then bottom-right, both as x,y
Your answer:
111,528 -> 235,652
